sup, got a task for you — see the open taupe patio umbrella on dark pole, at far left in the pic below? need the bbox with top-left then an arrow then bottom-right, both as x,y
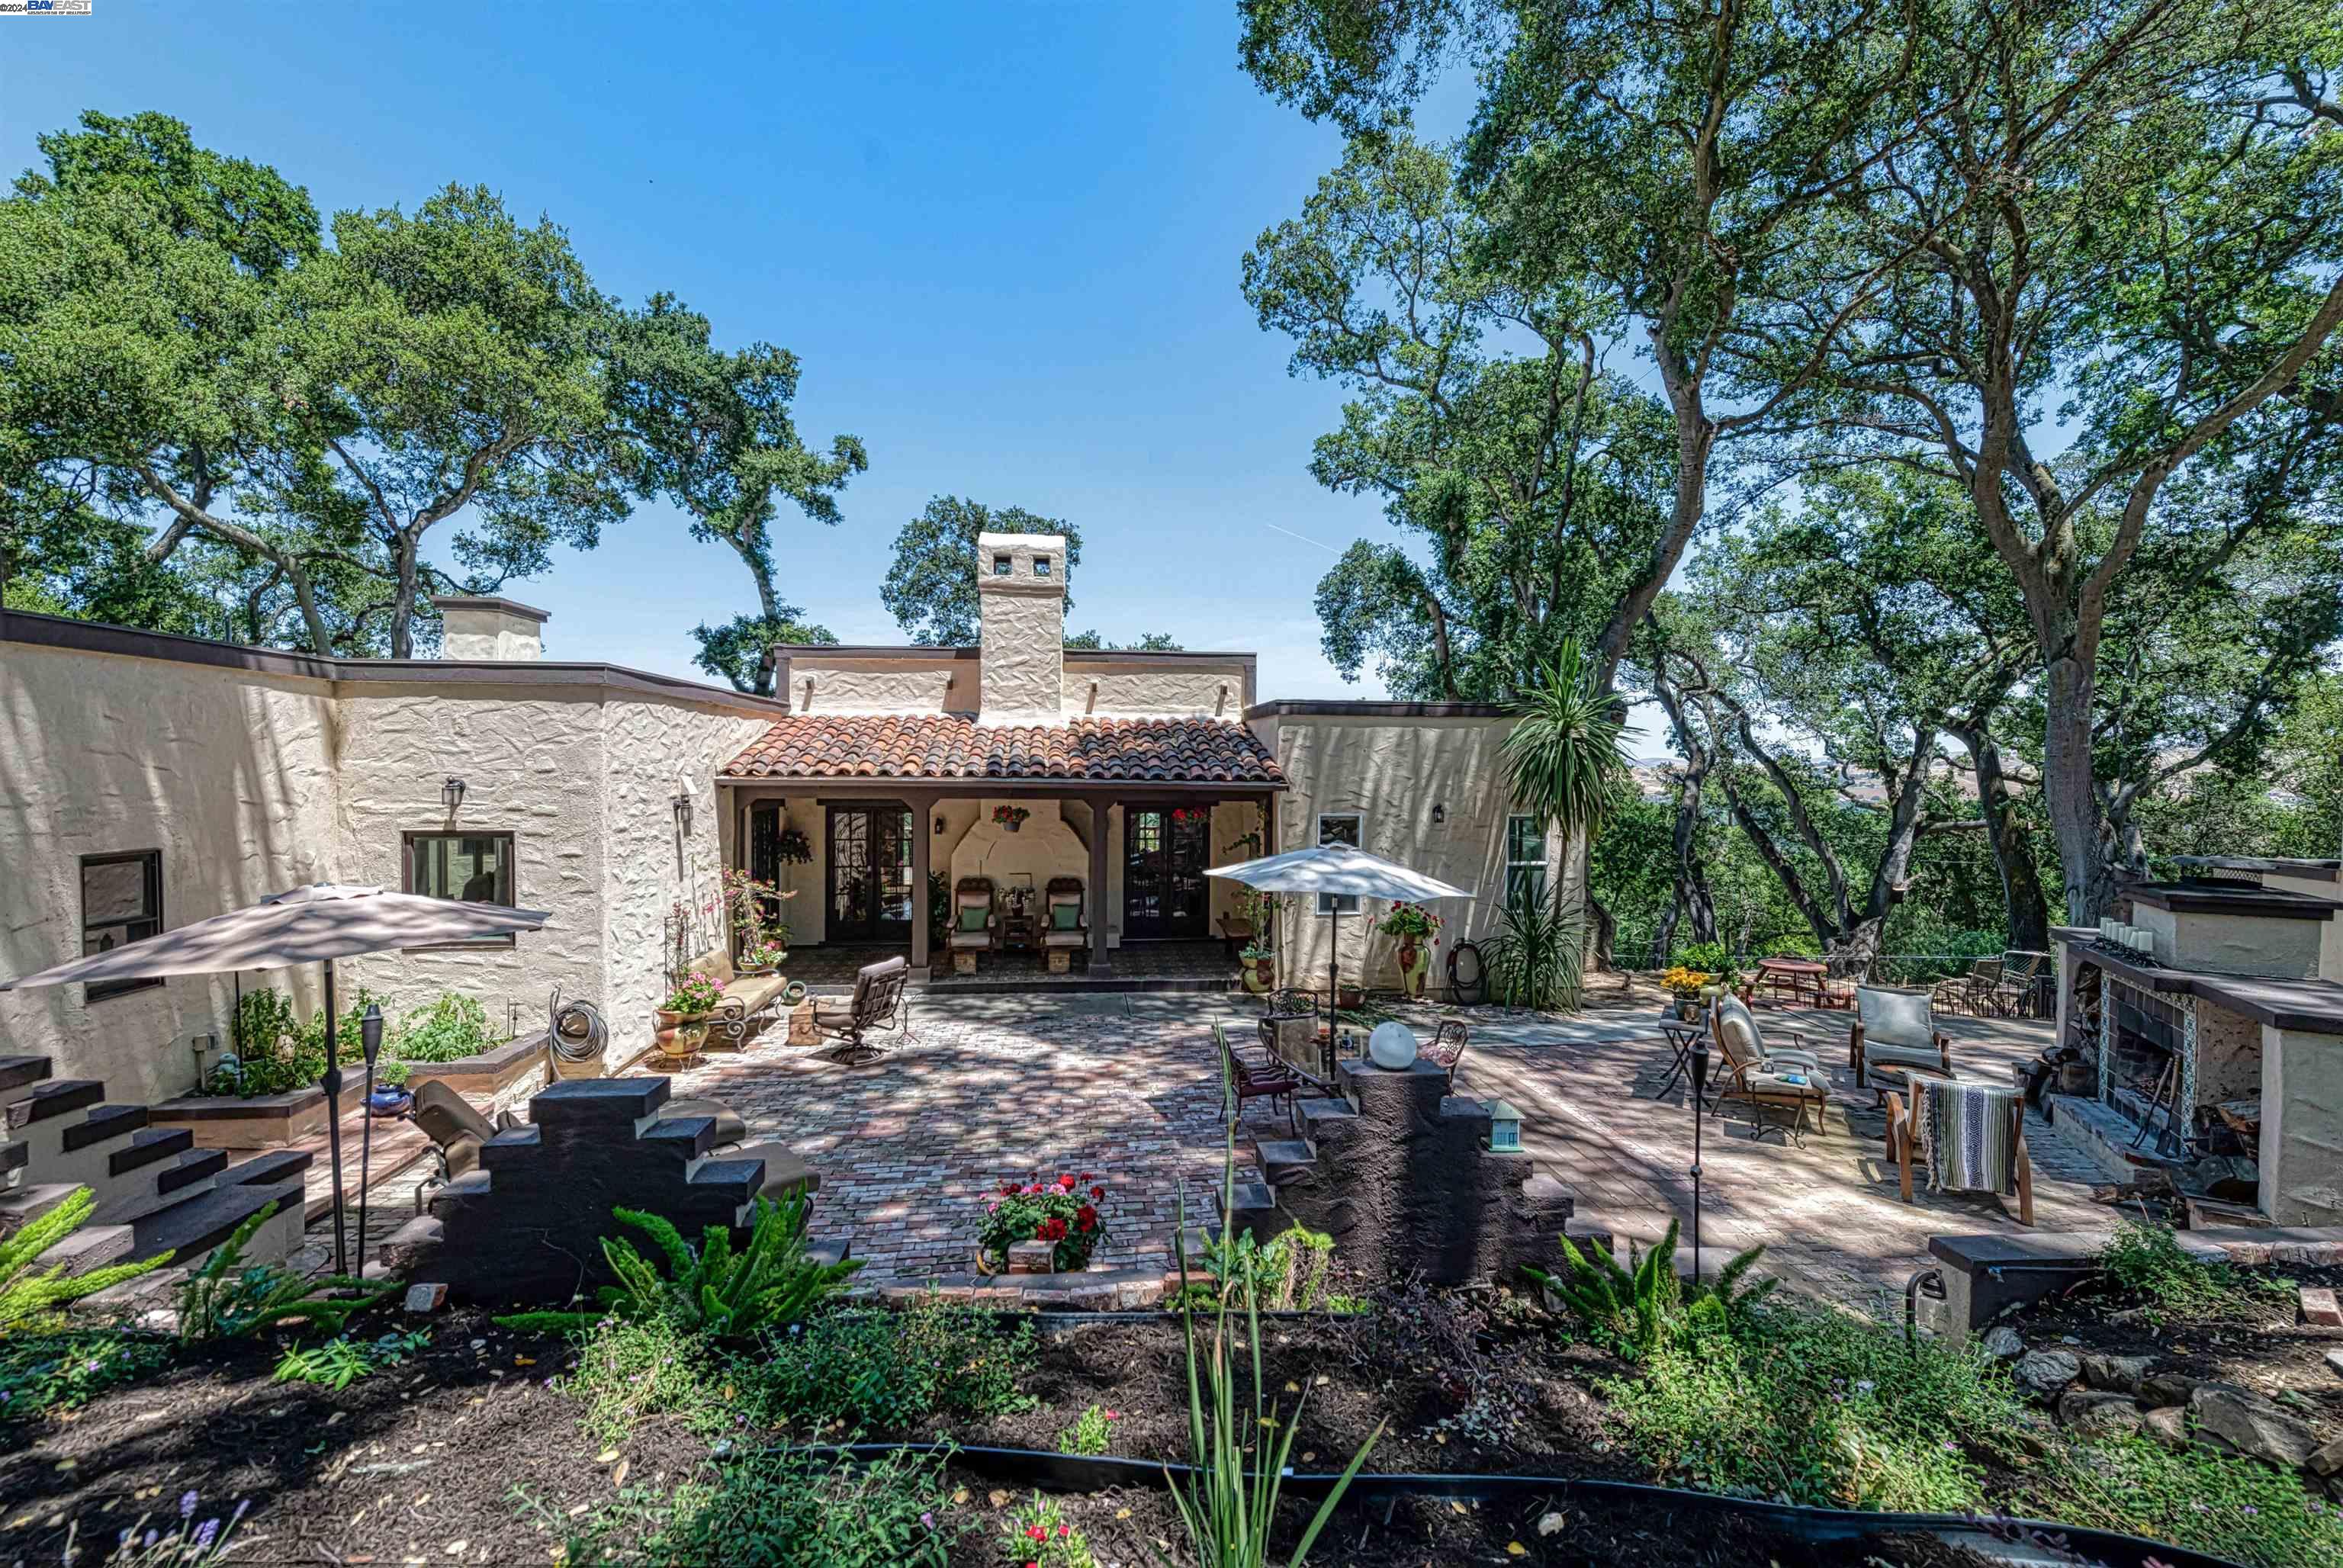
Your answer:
0,882 -> 551,1273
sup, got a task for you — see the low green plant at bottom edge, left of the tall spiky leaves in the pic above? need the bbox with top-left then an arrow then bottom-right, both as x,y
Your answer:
548,1448 -> 958,1568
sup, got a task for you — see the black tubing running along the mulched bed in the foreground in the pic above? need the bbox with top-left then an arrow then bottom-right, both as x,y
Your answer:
754,1444 -> 2242,1568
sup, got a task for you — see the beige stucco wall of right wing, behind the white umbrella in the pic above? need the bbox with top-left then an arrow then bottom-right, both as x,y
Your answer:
1255,715 -> 1576,987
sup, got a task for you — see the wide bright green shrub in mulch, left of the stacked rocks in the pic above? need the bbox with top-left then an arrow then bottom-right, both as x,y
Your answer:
1598,1303 -> 2029,1509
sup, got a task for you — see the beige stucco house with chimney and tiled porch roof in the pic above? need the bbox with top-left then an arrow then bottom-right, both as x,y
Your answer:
0,535 -> 1560,1099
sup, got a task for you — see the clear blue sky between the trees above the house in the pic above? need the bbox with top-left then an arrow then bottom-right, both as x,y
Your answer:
0,0 -> 1461,696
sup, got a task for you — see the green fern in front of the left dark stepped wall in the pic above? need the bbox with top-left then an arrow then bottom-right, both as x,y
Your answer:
603,1193 -> 862,1338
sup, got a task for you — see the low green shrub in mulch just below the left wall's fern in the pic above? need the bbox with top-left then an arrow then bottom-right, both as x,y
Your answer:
731,1296 -> 1033,1432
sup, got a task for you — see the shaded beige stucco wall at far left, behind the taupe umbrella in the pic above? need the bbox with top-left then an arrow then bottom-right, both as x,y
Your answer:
0,642 -> 339,1101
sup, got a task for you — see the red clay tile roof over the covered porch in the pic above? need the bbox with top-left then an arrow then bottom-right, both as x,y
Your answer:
724,712 -> 1287,786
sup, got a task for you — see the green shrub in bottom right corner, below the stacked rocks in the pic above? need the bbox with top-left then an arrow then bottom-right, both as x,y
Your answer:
2026,1437 -> 2343,1568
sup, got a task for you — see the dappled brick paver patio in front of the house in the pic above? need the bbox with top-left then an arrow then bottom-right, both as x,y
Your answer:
628,994 -> 2109,1308
